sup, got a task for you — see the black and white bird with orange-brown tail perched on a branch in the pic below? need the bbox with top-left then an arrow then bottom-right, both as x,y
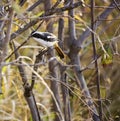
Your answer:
31,31 -> 64,58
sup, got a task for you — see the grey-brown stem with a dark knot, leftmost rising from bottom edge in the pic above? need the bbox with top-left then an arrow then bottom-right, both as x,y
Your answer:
13,43 -> 41,121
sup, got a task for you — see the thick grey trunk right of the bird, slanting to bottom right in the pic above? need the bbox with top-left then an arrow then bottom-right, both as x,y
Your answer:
69,0 -> 99,121
